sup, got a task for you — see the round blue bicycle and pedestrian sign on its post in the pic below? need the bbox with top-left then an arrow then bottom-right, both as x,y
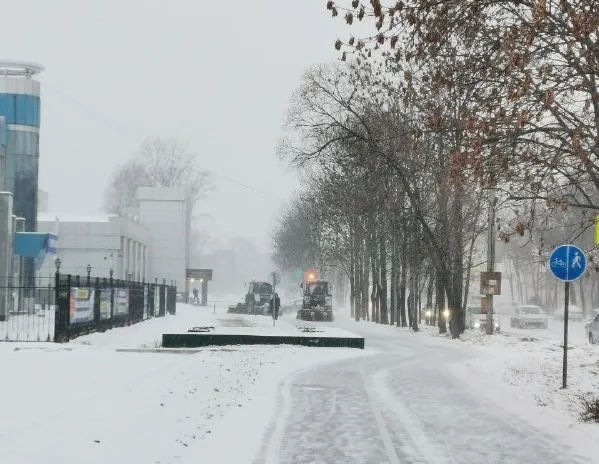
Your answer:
548,245 -> 587,388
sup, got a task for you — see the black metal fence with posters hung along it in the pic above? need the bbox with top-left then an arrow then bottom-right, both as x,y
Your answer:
0,273 -> 177,342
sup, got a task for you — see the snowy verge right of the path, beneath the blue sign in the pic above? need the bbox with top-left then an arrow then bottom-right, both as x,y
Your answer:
338,312 -> 599,457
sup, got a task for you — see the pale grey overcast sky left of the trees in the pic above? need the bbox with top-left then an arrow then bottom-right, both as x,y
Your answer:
0,0 -> 347,254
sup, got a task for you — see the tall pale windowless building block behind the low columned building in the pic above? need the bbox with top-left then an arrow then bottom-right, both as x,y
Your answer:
136,187 -> 187,289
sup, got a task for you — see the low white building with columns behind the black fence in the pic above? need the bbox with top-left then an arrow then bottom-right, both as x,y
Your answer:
38,213 -> 150,280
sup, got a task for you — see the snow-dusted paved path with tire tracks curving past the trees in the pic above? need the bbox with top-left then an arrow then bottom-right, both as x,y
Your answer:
254,322 -> 595,464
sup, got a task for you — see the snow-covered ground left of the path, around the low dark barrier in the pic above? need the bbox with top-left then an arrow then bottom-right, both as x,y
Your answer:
0,305 -> 366,464
